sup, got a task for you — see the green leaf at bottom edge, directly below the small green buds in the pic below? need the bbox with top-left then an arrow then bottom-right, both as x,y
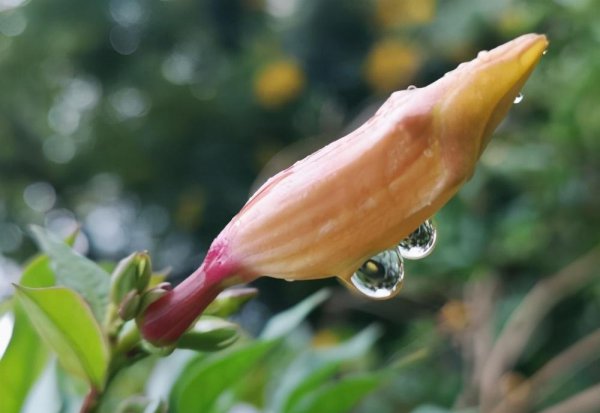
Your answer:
171,341 -> 276,413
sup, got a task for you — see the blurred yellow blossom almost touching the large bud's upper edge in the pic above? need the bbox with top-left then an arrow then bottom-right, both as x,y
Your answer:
365,39 -> 421,93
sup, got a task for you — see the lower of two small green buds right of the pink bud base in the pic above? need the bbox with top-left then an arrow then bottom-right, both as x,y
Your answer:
177,317 -> 239,351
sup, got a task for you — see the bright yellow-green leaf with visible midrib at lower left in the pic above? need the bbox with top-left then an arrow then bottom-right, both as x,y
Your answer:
15,286 -> 109,389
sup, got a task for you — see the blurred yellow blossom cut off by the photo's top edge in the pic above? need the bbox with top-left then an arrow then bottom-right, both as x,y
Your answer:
375,0 -> 436,28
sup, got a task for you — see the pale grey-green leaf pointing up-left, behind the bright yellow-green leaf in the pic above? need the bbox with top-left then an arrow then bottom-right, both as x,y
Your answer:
31,226 -> 110,321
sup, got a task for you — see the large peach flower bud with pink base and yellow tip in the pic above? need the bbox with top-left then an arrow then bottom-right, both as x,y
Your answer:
141,34 -> 548,343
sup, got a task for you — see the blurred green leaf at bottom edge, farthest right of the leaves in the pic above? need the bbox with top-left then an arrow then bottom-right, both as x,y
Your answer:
292,374 -> 384,413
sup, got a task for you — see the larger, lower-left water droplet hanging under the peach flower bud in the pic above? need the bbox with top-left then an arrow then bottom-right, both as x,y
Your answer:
350,248 -> 404,299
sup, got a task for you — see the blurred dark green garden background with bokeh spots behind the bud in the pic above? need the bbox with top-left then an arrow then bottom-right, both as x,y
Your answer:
0,0 -> 600,412
